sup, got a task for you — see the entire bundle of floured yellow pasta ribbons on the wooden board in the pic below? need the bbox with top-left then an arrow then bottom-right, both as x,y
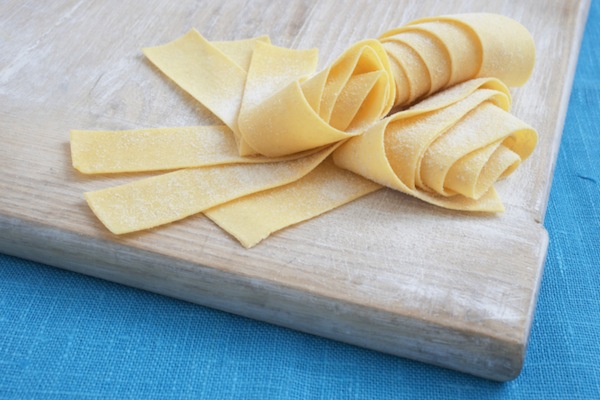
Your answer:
71,14 -> 537,247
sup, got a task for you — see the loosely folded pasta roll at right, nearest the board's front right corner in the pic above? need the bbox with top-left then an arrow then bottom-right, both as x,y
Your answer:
334,78 -> 537,212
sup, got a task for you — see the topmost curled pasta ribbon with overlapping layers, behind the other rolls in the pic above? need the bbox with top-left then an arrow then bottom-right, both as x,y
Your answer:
379,13 -> 535,107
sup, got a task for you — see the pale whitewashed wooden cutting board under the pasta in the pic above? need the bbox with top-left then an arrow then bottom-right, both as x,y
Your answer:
0,0 -> 589,381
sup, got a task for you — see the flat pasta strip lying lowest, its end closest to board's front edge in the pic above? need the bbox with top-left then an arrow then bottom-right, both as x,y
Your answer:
204,158 -> 381,248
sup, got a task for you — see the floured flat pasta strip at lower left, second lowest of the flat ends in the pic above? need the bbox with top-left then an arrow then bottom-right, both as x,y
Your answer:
85,147 -> 334,234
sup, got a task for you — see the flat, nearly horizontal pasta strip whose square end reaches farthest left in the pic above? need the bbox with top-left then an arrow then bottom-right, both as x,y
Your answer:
71,125 -> 319,174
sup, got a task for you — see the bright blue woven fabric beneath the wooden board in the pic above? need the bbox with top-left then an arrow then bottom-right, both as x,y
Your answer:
0,2 -> 600,399
